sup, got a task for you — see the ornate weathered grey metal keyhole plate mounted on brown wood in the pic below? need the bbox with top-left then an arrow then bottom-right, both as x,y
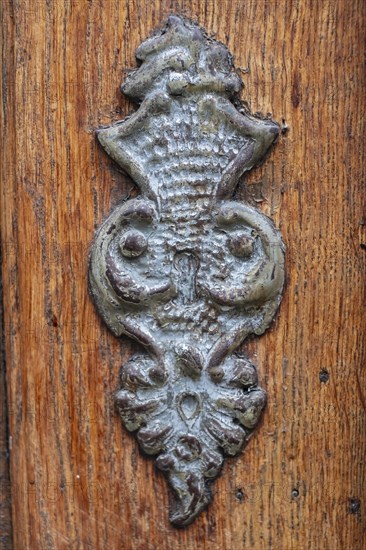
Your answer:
89,17 -> 284,526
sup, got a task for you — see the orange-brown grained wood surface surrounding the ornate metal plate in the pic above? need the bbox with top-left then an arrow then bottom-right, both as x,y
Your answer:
0,0 -> 366,550
